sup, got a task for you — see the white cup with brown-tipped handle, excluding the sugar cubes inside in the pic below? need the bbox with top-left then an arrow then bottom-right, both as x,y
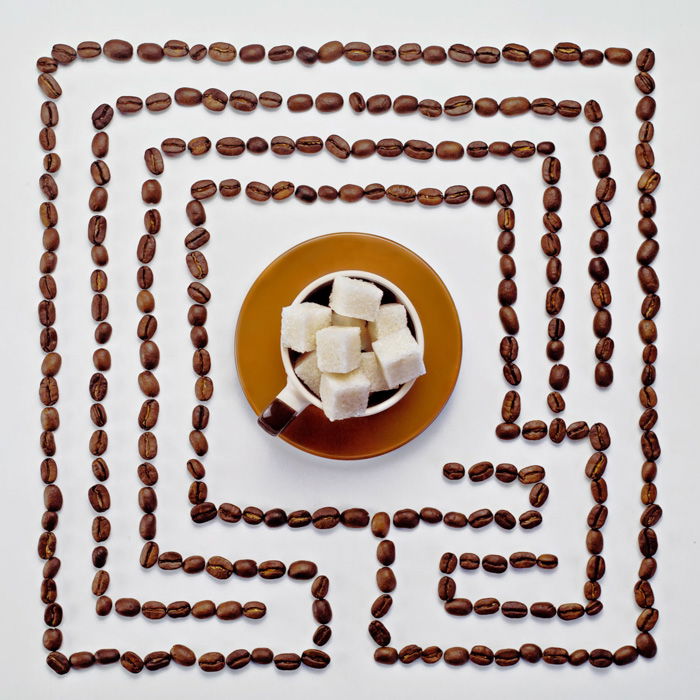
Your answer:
258,270 -> 425,435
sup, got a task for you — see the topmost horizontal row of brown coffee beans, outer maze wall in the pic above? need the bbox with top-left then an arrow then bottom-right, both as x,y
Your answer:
36,39 -> 643,75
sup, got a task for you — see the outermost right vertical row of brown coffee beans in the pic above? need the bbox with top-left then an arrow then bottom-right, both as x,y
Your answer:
633,49 -> 662,657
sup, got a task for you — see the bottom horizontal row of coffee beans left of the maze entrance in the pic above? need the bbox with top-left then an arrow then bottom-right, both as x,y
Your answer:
46,644 -> 331,675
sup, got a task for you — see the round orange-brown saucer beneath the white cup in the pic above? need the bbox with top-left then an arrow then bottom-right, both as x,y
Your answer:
235,233 -> 462,459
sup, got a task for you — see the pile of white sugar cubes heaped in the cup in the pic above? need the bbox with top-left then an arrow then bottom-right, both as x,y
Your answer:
282,276 -> 425,421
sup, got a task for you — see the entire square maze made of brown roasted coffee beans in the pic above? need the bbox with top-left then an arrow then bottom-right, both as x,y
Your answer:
37,40 -> 661,674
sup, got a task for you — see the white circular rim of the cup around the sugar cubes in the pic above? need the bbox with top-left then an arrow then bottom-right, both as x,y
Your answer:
280,270 -> 425,418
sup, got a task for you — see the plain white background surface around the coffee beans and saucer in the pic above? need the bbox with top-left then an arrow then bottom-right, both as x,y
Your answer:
0,0 -> 700,698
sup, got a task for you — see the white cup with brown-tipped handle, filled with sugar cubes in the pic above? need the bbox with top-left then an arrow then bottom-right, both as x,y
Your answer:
258,270 -> 425,435
